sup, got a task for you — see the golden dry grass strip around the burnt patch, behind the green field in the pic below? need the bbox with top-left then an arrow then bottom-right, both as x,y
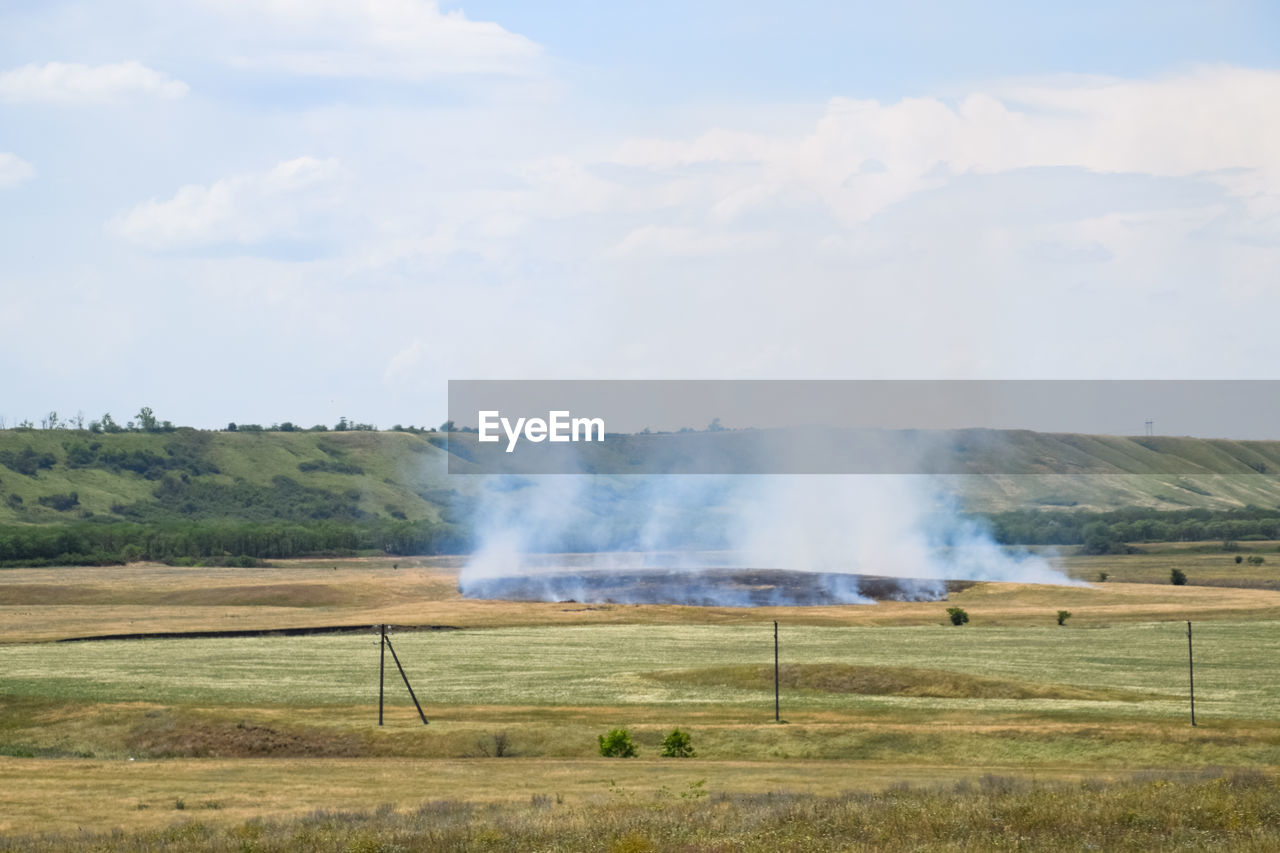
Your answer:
0,551 -> 1280,644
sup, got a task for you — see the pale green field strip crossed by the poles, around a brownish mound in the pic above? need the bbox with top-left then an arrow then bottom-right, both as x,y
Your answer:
0,621 -> 1280,721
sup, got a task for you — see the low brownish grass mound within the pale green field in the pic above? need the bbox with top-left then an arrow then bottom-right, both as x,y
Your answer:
653,663 -> 1152,702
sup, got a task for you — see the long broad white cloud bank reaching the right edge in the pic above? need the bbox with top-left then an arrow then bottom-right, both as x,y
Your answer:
611,67 -> 1280,227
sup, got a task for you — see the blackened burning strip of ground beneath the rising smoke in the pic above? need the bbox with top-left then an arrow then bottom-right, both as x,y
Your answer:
458,567 -> 947,607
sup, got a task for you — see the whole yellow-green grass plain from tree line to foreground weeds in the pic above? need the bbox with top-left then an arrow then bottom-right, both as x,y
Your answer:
0,551 -> 1280,849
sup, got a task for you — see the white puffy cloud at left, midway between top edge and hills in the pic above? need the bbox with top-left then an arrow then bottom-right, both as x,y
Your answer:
109,156 -> 342,251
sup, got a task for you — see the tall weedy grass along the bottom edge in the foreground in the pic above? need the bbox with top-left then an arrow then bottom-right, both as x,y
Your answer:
0,774 -> 1280,853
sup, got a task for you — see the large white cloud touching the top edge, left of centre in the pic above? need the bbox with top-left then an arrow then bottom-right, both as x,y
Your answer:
211,0 -> 541,81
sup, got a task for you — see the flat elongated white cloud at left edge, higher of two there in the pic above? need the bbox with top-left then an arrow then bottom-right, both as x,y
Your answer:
0,61 -> 187,104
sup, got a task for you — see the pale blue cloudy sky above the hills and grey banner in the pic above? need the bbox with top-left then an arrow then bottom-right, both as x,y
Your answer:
0,0 -> 1280,432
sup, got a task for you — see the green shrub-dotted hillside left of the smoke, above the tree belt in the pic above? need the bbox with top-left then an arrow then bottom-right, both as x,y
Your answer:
0,429 -> 466,524
